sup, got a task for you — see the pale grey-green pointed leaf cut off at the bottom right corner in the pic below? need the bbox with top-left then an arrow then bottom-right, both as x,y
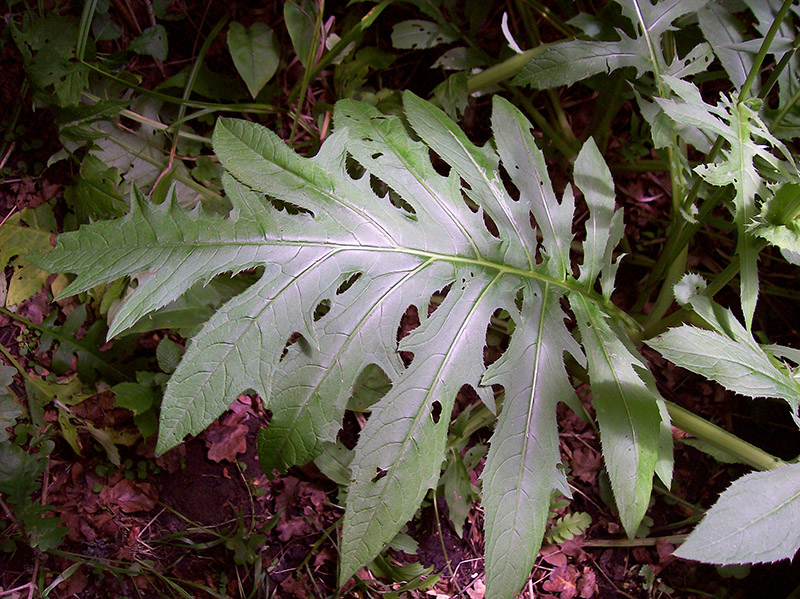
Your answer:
675,464 -> 800,565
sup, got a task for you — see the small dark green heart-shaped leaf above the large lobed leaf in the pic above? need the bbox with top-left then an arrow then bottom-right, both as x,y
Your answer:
228,22 -> 280,98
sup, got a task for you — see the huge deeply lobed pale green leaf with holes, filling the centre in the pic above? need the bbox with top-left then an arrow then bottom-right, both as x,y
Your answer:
32,93 -> 669,598
